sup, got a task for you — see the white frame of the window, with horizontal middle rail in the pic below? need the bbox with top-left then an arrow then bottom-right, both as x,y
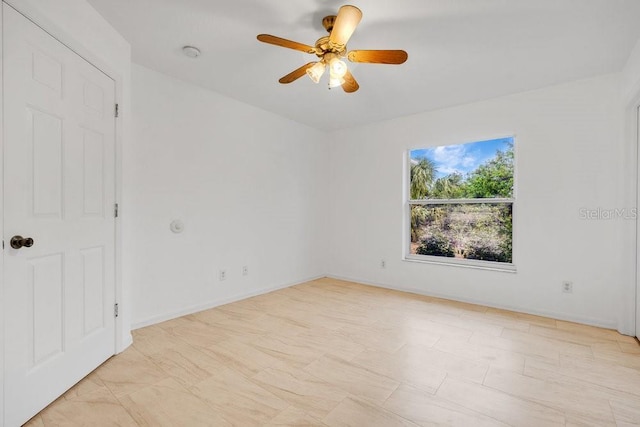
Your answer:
403,135 -> 517,273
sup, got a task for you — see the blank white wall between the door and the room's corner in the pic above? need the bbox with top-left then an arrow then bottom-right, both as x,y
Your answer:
130,65 -> 328,326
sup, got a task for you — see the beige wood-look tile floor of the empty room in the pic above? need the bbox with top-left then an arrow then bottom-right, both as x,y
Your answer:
22,279 -> 640,427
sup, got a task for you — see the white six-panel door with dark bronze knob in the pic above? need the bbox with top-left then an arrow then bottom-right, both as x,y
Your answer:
3,3 -> 115,426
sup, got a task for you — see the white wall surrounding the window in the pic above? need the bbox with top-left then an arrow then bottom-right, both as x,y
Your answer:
328,75 -> 634,327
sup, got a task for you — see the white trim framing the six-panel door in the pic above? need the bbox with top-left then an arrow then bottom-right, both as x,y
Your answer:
0,0 -> 133,425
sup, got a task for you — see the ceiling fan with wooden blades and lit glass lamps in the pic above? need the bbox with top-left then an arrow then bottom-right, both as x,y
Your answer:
258,5 -> 408,93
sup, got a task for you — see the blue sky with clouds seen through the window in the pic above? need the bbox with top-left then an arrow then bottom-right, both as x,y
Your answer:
411,137 -> 513,178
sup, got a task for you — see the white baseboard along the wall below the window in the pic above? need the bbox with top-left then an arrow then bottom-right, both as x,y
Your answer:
326,274 -> 622,333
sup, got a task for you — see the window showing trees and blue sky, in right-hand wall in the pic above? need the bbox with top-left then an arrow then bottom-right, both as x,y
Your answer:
405,137 -> 515,269
